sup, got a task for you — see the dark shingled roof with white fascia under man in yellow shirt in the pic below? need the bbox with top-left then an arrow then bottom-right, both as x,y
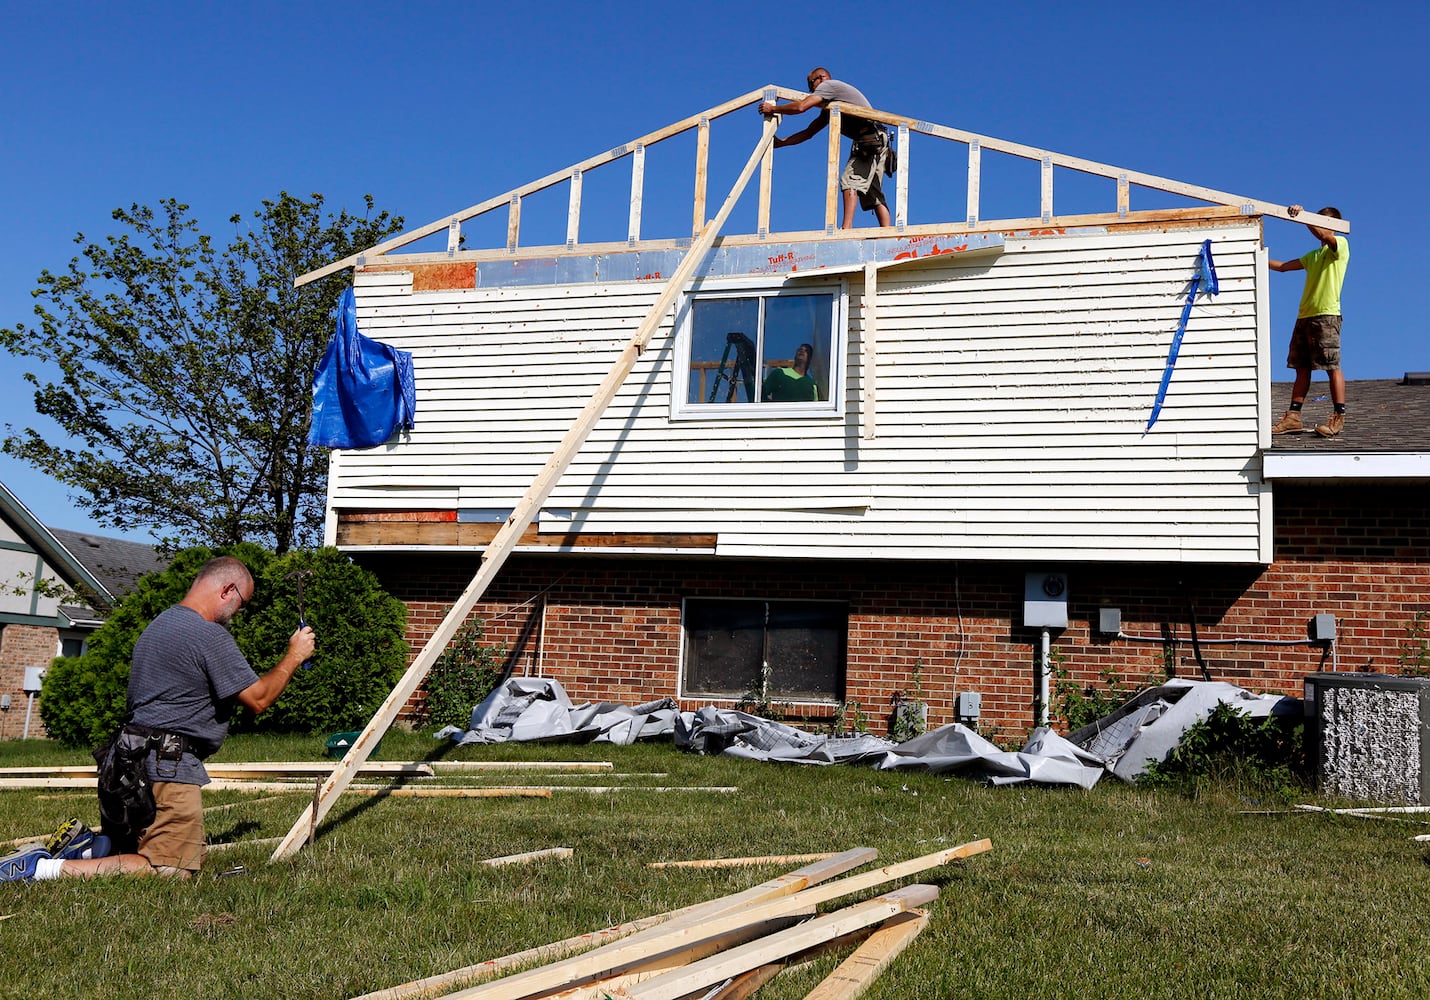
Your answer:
1263,372 -> 1430,479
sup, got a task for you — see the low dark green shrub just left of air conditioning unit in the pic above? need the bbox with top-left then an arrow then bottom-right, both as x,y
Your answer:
1137,702 -> 1308,797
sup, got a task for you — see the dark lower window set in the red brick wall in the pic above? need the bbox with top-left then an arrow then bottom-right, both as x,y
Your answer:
682,598 -> 849,702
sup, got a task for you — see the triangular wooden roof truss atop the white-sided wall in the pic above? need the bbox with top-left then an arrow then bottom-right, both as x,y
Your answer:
295,84 -> 1350,285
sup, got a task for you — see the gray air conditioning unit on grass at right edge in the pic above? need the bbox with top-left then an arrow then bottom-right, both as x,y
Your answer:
1306,674 -> 1430,805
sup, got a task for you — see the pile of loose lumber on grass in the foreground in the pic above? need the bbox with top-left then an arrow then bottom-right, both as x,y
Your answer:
356,840 -> 992,1000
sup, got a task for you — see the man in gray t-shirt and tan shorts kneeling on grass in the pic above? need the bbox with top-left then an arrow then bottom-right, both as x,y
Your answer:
0,557 -> 313,881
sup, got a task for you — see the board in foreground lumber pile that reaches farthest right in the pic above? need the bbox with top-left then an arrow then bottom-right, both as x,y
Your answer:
440,840 -> 992,1000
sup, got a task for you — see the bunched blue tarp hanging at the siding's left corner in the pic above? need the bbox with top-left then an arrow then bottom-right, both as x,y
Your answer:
307,288 -> 418,448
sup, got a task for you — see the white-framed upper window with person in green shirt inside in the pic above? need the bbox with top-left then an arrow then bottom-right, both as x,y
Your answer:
672,285 -> 844,419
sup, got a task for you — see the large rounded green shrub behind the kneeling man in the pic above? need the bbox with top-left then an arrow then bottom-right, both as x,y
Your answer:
40,542 -> 406,747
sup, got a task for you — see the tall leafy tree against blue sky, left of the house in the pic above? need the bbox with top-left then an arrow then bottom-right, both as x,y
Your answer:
0,192 -> 402,554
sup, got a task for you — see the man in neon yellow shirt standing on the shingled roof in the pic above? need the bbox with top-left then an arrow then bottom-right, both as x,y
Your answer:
1267,205 -> 1350,438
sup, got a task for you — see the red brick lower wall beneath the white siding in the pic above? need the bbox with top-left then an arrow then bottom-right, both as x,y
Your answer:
358,485 -> 1430,737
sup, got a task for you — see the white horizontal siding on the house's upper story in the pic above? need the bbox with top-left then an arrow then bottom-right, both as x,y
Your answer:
330,220 -> 1270,562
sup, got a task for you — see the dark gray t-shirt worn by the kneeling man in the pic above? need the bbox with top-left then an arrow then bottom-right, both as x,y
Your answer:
129,604 -> 259,785
